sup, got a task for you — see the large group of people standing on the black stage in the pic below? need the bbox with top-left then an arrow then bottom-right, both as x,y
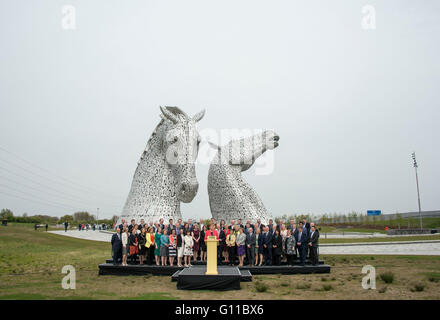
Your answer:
111,219 -> 319,267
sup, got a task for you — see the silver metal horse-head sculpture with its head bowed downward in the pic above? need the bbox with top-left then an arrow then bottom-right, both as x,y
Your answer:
121,107 -> 205,222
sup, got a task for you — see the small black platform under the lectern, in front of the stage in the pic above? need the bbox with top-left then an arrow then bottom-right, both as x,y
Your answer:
173,266 -> 246,291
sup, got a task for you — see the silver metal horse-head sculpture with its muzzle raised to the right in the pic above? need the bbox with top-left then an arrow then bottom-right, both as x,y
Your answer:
208,131 -> 279,224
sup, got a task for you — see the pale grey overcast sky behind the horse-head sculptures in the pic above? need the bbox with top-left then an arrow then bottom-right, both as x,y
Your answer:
0,0 -> 440,218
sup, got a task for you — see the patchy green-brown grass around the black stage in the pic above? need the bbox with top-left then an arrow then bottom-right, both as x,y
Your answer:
0,223 -> 440,299
